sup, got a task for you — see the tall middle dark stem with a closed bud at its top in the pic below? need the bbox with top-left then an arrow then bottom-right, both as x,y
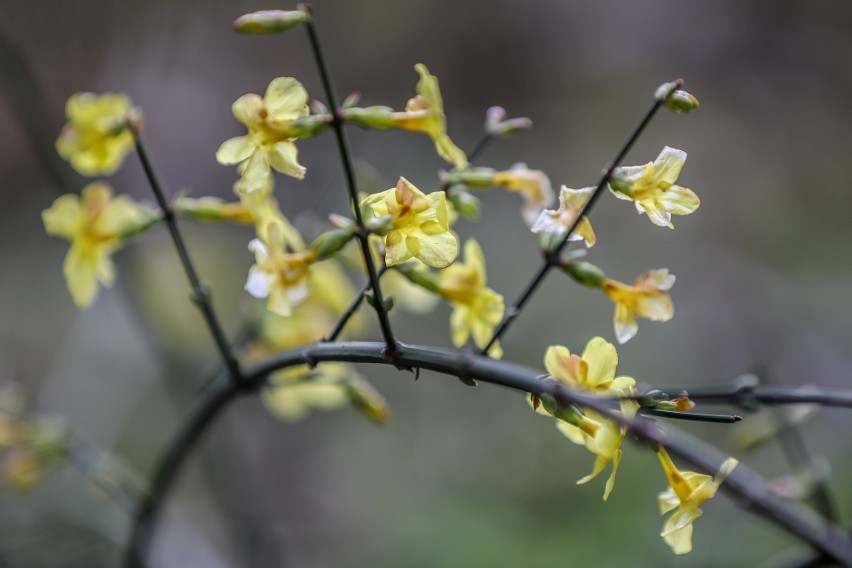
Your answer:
299,4 -> 397,355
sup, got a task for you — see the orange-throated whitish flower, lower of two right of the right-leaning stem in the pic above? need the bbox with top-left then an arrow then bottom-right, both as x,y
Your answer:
601,268 -> 675,343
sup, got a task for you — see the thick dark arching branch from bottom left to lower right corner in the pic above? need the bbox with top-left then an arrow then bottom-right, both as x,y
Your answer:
129,342 -> 852,566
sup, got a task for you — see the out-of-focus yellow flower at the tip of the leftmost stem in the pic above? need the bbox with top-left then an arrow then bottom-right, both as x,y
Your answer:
56,93 -> 134,176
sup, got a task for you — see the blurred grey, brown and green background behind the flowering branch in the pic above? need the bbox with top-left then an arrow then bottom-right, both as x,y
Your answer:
0,0 -> 852,567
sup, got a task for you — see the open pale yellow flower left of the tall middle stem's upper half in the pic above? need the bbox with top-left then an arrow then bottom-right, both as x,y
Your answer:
216,77 -> 308,193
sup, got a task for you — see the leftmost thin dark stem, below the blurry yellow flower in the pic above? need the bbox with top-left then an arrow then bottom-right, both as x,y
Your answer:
128,124 -> 243,382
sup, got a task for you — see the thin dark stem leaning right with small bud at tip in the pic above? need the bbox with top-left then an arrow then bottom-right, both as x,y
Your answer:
480,79 -> 683,354
